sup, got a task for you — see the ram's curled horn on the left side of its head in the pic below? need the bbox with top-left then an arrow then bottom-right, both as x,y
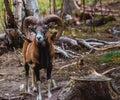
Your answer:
23,16 -> 39,34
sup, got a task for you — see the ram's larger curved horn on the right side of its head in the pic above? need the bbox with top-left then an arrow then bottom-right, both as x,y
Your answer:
41,14 -> 63,40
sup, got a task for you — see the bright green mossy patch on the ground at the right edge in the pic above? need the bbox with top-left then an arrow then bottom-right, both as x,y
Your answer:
96,51 -> 120,63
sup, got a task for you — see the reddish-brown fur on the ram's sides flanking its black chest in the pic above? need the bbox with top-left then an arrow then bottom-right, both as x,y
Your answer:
22,32 -> 54,64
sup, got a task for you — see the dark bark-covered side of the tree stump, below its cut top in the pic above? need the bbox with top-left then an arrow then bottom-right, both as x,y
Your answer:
58,81 -> 112,100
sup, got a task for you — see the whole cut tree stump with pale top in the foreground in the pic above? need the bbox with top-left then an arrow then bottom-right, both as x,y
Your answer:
57,69 -> 112,100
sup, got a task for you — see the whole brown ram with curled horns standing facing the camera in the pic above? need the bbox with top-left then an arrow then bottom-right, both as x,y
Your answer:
22,15 -> 63,97
